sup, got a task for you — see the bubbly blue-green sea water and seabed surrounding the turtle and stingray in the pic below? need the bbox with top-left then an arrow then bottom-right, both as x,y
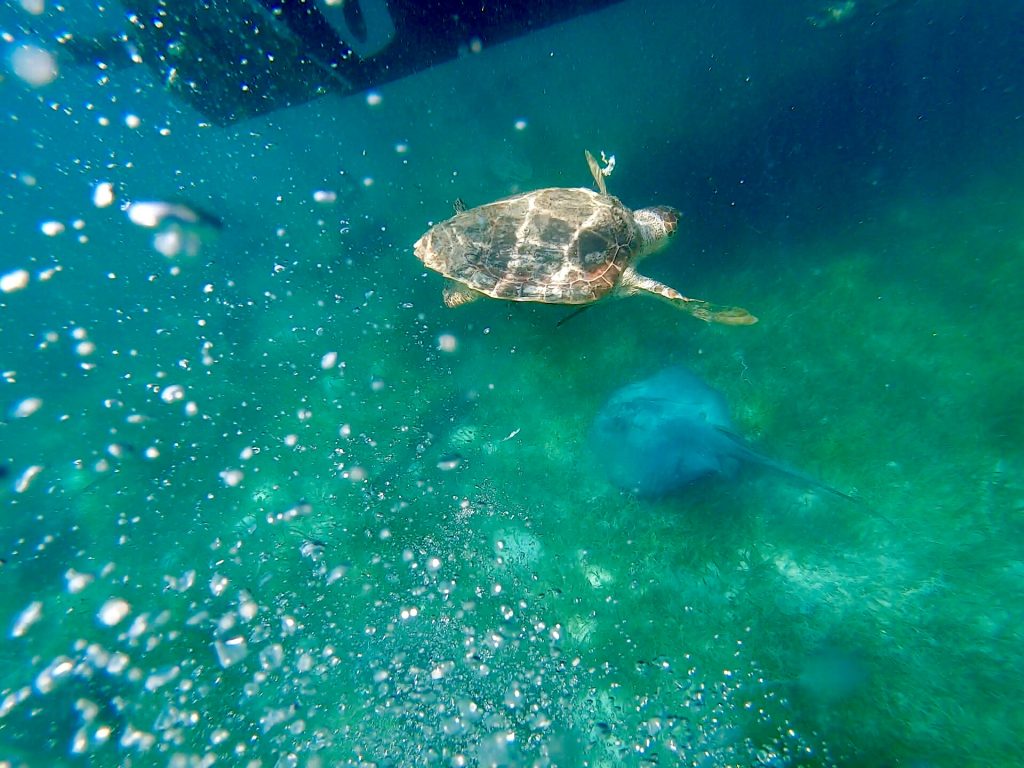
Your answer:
0,0 -> 1024,768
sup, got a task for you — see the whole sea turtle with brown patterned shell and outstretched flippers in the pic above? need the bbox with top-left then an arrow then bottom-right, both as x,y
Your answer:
414,152 -> 757,326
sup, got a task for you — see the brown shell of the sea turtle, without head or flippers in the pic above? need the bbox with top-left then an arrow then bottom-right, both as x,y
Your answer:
415,187 -> 641,304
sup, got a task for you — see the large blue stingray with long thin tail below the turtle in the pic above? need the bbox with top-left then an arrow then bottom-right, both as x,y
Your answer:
590,368 -> 851,499
